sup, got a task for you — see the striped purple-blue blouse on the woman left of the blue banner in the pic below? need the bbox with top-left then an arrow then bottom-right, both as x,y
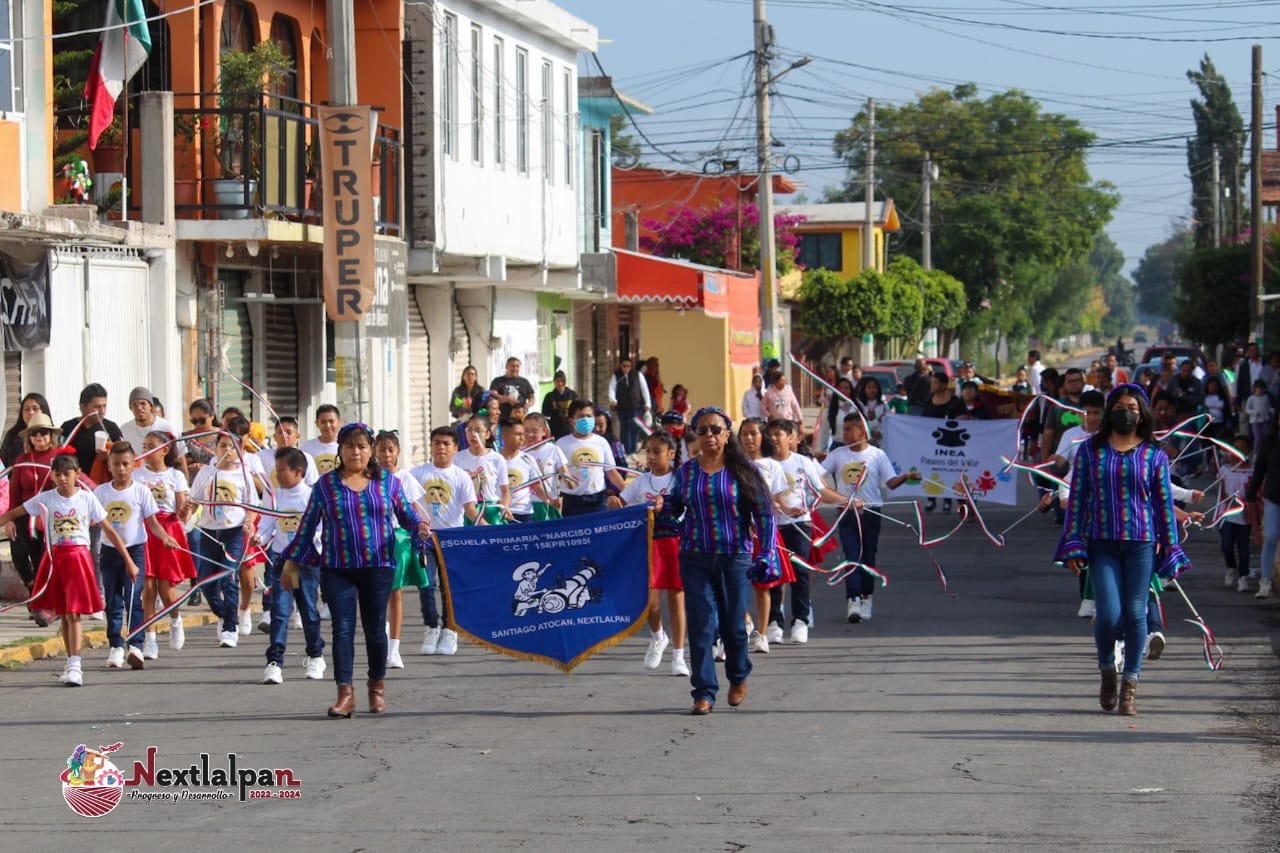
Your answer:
284,471 -> 424,569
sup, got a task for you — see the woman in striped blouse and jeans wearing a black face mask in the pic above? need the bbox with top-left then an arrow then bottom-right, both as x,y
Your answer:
1057,384 -> 1190,716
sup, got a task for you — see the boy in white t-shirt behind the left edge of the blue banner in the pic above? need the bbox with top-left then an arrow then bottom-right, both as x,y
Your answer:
410,427 -> 485,654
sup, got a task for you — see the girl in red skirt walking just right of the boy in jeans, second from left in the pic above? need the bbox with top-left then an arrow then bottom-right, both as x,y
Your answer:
134,433 -> 196,654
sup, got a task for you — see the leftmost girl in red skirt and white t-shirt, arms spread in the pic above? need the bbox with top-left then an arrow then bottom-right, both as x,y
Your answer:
0,448 -> 138,686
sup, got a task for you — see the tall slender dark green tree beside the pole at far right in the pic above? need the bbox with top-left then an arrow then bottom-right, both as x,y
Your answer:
1187,54 -> 1244,246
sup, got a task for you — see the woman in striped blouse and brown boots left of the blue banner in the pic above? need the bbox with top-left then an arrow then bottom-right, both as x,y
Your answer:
284,424 -> 431,717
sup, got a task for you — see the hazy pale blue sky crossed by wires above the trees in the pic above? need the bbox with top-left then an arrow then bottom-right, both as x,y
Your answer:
558,0 -> 1280,270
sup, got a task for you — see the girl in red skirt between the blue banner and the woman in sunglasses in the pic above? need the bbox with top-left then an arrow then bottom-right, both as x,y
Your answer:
608,430 -> 689,676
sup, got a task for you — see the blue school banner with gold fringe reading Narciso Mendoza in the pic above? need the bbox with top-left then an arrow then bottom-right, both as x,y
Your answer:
436,506 -> 652,672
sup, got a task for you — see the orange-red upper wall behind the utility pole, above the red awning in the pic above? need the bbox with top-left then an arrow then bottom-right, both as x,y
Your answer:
612,169 -> 796,248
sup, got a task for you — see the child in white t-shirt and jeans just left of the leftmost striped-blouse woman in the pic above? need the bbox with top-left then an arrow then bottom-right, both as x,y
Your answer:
257,447 -> 325,684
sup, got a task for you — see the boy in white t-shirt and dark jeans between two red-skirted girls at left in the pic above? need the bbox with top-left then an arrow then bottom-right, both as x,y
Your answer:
93,441 -> 178,670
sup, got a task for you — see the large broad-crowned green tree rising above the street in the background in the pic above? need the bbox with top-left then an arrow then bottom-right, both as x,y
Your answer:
832,83 -> 1119,339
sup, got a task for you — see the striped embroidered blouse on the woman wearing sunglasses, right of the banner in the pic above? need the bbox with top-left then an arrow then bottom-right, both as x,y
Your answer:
657,460 -> 778,560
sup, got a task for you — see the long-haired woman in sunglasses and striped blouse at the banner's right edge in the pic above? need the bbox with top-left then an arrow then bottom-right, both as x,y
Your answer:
659,406 -> 781,715
